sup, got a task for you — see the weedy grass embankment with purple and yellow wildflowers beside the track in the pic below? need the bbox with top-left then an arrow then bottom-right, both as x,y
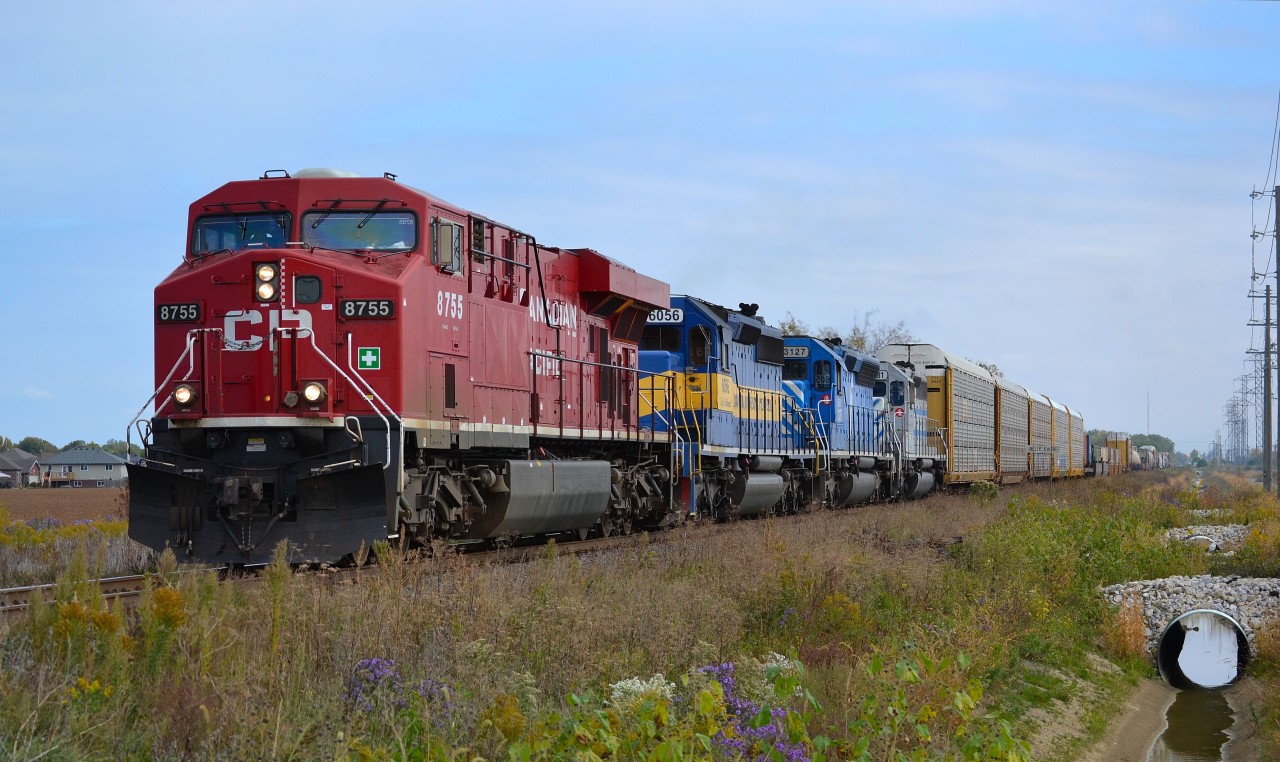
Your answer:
0,473 -> 1280,759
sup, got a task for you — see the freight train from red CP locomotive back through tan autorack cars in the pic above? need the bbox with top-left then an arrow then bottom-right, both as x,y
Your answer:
129,170 -> 1089,563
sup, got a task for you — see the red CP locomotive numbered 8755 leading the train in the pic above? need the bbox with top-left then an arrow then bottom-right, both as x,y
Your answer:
129,170 -> 677,563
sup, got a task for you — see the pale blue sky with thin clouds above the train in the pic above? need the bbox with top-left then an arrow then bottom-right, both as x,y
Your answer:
0,0 -> 1280,451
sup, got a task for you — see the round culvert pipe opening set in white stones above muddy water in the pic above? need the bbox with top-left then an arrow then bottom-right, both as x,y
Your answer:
1156,608 -> 1249,689
